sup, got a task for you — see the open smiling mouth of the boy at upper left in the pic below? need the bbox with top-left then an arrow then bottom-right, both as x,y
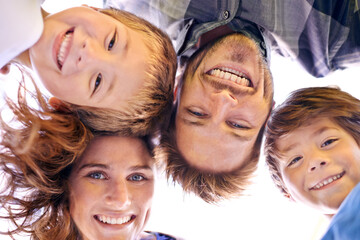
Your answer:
54,28 -> 74,71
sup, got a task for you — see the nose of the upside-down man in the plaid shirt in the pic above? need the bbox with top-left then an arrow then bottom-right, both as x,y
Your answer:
212,90 -> 239,122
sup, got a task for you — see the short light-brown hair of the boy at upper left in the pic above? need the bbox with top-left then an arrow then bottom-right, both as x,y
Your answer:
69,9 -> 176,136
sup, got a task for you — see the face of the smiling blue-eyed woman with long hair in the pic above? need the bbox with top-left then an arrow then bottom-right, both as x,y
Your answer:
69,136 -> 154,240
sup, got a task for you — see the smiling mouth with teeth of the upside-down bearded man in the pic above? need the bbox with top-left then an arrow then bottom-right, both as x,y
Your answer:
206,67 -> 253,87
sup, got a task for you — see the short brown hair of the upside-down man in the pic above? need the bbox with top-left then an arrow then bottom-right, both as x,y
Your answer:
159,116 -> 264,203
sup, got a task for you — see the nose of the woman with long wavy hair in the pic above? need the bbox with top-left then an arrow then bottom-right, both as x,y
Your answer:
105,180 -> 131,210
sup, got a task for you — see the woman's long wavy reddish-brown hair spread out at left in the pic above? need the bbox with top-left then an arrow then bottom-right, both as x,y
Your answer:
0,72 -> 92,240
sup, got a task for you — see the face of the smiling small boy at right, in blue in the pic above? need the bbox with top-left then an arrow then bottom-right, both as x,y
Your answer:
277,118 -> 360,214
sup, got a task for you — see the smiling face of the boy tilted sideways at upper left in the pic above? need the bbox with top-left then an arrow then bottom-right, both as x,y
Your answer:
29,7 -> 150,110
